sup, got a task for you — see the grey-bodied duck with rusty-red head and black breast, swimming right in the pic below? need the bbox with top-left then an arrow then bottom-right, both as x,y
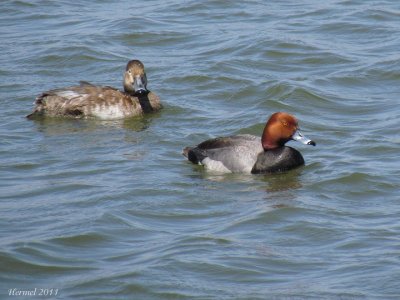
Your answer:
183,112 -> 316,174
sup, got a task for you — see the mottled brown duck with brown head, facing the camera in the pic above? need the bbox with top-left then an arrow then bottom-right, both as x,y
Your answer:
27,60 -> 162,119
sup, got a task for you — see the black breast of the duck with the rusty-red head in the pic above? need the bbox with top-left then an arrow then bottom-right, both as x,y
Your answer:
251,146 -> 304,174
